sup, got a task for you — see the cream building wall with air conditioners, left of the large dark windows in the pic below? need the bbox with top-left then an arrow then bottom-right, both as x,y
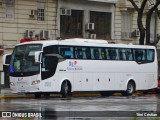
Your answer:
0,0 -> 57,70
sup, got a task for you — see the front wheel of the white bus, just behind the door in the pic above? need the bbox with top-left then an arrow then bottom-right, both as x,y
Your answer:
61,81 -> 71,98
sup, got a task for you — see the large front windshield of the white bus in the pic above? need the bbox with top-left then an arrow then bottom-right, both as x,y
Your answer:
9,44 -> 42,76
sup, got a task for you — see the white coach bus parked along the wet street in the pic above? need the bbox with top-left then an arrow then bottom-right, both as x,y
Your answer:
3,38 -> 158,98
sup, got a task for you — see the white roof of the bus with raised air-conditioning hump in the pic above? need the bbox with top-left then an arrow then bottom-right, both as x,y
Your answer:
16,38 -> 155,49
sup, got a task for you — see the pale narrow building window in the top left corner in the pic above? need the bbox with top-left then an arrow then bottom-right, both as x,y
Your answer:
5,0 -> 15,19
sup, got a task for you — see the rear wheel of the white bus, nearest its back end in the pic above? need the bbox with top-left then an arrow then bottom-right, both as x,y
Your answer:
121,81 -> 135,96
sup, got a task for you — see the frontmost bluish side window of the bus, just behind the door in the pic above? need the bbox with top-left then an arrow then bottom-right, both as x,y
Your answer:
59,46 -> 74,59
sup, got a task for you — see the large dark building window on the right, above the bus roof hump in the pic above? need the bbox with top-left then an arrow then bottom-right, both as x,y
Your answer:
90,11 -> 112,39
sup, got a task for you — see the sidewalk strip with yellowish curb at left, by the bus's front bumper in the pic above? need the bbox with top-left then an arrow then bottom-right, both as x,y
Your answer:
0,88 -> 31,99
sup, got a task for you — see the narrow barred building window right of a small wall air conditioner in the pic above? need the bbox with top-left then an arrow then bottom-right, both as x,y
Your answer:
37,0 -> 45,21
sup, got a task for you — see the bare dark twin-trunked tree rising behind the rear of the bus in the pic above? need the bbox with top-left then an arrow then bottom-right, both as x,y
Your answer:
129,0 -> 160,45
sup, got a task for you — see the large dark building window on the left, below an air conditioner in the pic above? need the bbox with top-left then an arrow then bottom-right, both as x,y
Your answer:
60,10 -> 83,38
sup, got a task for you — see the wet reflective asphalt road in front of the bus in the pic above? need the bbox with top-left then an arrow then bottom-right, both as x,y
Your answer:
0,94 -> 160,120
